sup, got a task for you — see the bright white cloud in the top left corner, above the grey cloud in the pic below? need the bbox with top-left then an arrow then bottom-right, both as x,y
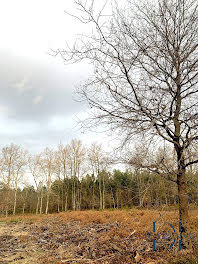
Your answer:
0,0 -> 86,60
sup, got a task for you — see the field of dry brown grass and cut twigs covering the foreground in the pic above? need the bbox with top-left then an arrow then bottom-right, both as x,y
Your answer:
0,209 -> 198,264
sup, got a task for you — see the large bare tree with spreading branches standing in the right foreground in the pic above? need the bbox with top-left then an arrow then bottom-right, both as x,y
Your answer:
56,0 -> 198,244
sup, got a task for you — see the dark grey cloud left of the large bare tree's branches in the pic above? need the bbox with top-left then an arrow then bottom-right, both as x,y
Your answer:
0,50 -> 88,122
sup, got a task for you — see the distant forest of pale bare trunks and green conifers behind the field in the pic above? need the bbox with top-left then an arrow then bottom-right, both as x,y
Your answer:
0,139 -> 198,216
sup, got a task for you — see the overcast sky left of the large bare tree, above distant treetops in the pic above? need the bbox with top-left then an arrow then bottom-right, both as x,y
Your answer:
0,0 -> 113,152
